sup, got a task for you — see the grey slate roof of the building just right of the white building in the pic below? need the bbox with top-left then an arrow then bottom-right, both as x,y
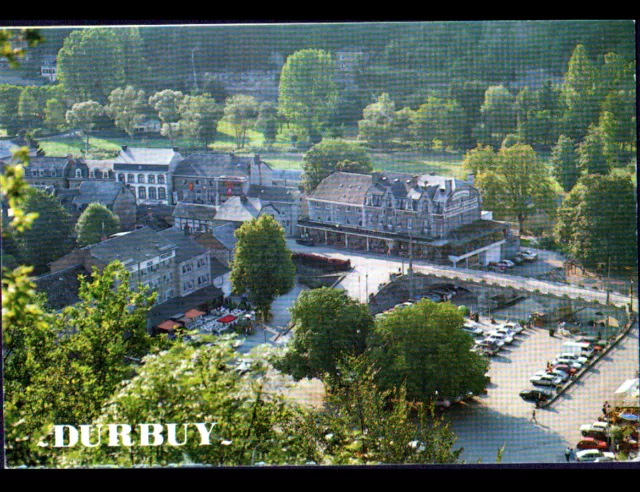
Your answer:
173,152 -> 254,178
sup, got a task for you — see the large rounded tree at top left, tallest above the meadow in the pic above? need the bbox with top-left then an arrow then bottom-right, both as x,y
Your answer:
57,28 -> 127,103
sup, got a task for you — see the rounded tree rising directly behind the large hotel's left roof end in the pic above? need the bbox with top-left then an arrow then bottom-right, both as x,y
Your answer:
302,139 -> 373,191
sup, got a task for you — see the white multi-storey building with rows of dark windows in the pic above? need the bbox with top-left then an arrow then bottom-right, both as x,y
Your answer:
113,145 -> 182,205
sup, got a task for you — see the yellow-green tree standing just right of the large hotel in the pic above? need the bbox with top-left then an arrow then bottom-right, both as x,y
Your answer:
475,144 -> 555,231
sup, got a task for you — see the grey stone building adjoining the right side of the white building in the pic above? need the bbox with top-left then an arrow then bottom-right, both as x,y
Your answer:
173,152 -> 273,206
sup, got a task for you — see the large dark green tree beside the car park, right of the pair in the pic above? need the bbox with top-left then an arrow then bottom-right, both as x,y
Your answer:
368,300 -> 488,403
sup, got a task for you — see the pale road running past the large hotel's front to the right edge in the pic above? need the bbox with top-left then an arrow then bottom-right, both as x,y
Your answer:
287,239 -> 638,311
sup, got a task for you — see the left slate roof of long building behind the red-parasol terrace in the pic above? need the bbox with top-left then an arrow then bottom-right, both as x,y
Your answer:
85,227 -> 176,264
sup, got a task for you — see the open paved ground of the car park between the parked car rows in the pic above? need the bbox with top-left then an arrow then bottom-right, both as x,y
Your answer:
446,318 -> 638,463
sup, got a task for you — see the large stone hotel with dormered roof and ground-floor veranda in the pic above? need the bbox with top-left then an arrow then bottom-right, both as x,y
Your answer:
298,172 -> 513,266
